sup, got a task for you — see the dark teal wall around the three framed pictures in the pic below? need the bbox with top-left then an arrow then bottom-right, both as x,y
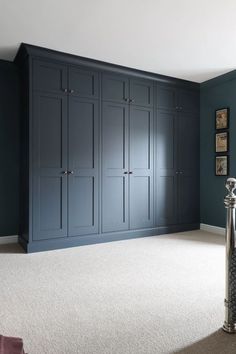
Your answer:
200,71 -> 236,227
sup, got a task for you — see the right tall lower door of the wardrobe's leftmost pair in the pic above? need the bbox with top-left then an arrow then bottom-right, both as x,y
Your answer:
68,97 -> 98,236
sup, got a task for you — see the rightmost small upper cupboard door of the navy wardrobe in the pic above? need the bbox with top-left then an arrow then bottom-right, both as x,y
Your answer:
178,90 -> 200,113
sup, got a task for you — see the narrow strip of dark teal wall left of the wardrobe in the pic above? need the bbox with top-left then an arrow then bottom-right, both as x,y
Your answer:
0,60 -> 20,236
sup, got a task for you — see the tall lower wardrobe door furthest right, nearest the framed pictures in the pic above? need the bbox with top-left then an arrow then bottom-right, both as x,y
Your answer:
178,113 -> 199,224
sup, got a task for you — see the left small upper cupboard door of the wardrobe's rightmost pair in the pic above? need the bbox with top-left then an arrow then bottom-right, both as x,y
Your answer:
157,85 -> 177,110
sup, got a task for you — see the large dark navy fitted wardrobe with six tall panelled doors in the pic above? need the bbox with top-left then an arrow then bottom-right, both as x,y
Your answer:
15,44 -> 199,252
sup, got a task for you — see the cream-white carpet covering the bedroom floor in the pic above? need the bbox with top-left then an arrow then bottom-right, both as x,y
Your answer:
0,231 -> 236,354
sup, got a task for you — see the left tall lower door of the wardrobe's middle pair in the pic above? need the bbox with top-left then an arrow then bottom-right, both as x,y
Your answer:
102,102 -> 128,232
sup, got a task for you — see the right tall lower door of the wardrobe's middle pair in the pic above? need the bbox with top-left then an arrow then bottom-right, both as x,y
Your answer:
129,106 -> 153,229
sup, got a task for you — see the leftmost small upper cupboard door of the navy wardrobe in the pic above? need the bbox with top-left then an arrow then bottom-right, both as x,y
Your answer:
33,60 -> 67,94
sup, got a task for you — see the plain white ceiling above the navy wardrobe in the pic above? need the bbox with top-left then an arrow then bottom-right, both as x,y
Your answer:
0,0 -> 236,82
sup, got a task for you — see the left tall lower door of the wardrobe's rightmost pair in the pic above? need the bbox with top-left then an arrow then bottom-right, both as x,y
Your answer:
156,110 -> 178,226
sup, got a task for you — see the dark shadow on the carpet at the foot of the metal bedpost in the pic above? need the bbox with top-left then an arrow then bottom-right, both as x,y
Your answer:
174,329 -> 236,354
